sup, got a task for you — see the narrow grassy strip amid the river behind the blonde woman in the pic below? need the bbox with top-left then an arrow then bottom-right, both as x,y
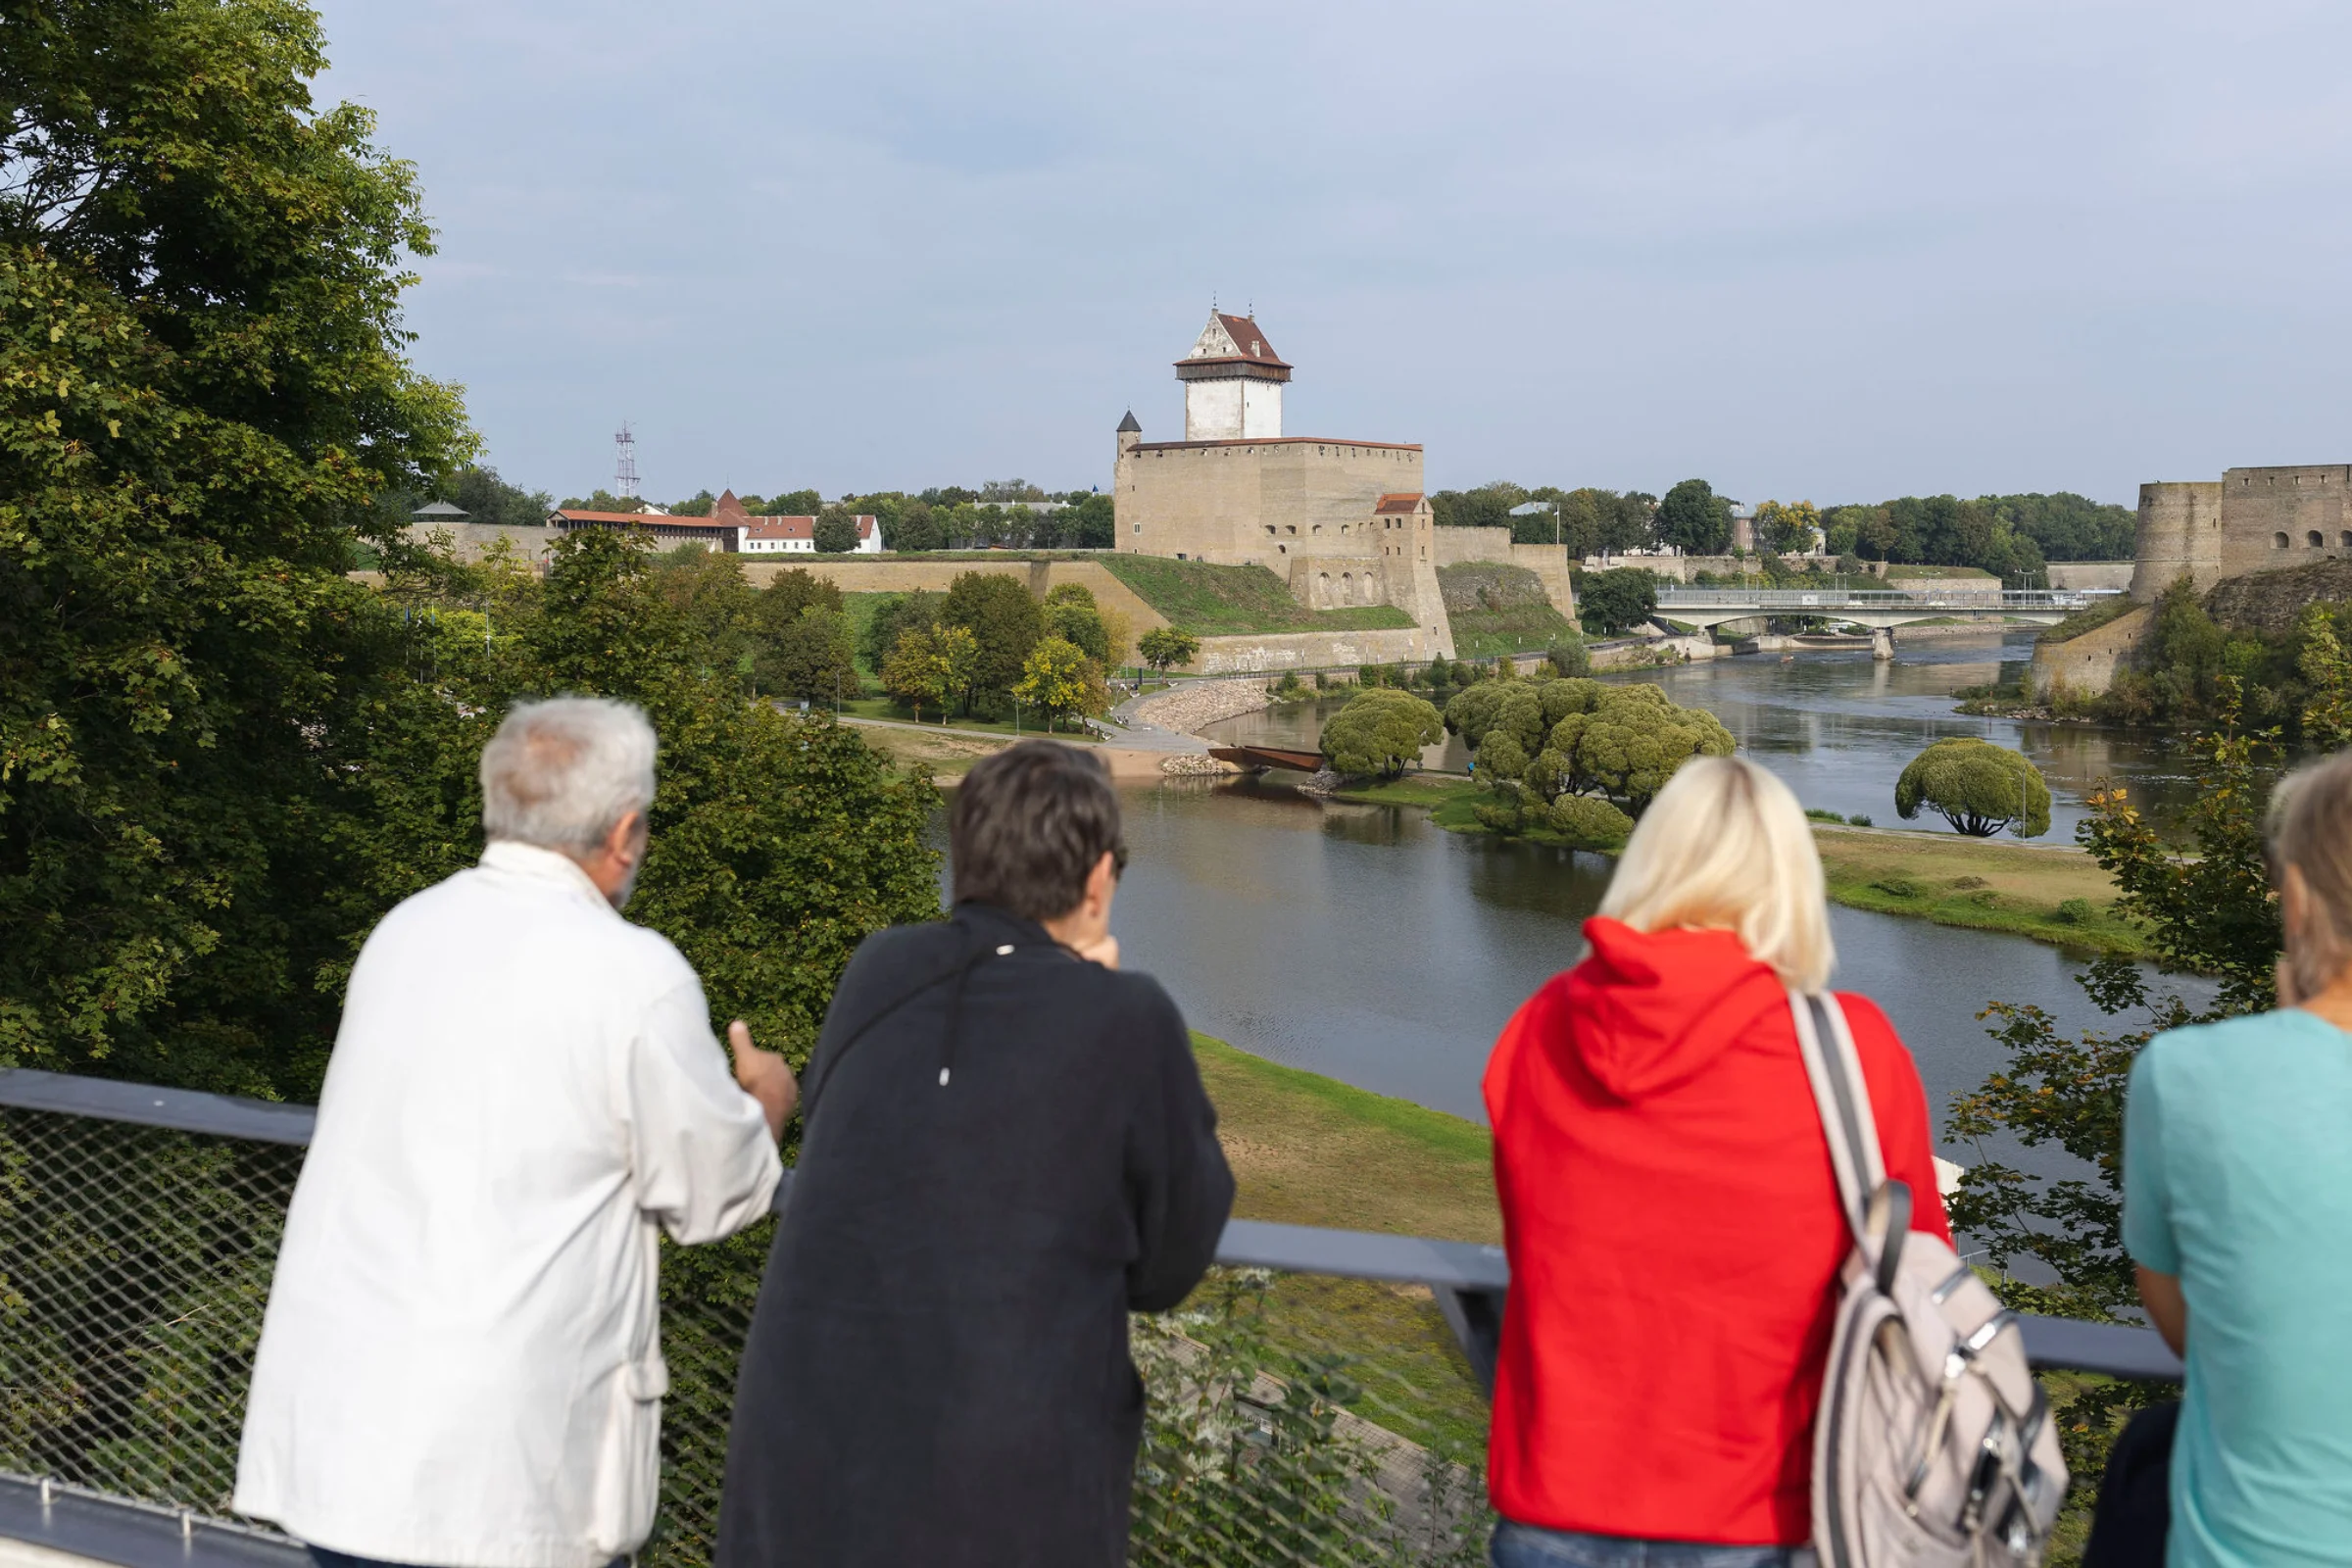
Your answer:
1331,773 -> 2147,956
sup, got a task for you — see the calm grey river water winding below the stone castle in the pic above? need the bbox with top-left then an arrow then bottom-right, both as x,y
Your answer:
1091,639 -> 2206,1163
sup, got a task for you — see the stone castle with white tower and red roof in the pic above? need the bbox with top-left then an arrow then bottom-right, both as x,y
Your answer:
1112,311 -> 1453,659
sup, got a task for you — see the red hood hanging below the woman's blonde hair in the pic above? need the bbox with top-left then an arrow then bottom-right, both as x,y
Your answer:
1566,917 -> 1788,1101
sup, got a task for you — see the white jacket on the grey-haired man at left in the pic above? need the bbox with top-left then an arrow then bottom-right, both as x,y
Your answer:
235,844 -> 781,1568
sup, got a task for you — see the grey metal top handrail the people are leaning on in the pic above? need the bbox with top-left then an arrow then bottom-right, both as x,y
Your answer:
0,1067 -> 2180,1378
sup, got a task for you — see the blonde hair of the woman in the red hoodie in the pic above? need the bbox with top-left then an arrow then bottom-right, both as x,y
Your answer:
1599,757 -> 1837,992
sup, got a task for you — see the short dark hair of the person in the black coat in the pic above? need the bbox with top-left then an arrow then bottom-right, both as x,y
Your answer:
948,741 -> 1127,921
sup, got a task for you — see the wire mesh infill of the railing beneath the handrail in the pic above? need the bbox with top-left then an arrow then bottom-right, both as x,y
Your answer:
0,1107 -> 1492,1568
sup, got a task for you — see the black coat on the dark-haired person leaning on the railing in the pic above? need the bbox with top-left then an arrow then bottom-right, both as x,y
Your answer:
717,906 -> 1233,1568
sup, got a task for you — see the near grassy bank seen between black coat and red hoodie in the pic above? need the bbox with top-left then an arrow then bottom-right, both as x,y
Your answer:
1193,1034 -> 1503,1462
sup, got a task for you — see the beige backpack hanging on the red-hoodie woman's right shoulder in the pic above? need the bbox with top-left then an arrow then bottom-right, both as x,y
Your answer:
1789,992 -> 2068,1568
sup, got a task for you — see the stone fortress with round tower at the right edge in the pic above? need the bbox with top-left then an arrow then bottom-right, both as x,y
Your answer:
2131,464 -> 2352,604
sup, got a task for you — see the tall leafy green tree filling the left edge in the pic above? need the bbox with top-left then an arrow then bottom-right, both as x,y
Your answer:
0,0 -> 472,1093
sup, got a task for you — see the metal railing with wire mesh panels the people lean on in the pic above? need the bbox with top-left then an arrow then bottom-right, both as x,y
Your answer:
0,1072 -> 2178,1568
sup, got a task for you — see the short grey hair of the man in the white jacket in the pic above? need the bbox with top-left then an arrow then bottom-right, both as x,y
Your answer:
482,696 -> 654,854
